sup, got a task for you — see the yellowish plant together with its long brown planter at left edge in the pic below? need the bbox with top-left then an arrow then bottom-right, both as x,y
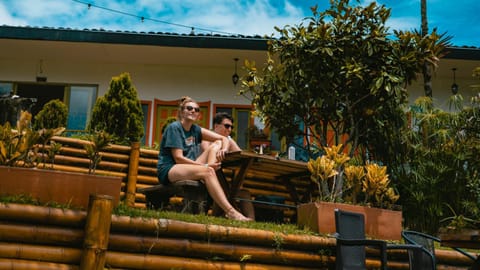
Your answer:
0,112 -> 122,208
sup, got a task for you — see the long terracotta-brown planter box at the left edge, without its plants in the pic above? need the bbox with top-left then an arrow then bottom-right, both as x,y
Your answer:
0,167 -> 122,209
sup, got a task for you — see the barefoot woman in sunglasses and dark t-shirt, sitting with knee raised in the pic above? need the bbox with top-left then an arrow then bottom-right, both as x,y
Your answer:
157,97 -> 251,221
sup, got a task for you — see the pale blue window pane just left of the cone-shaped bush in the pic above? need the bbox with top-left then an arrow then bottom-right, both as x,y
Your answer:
67,86 -> 97,130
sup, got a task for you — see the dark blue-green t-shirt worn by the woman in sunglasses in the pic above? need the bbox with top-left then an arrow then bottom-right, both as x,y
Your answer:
157,121 -> 202,184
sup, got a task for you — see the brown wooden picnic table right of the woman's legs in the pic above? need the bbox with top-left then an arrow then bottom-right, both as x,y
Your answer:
218,151 -> 316,205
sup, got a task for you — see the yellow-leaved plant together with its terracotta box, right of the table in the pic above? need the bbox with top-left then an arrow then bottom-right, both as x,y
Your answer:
297,144 -> 402,240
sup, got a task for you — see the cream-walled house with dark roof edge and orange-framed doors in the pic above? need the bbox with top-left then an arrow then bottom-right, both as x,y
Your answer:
0,25 -> 480,148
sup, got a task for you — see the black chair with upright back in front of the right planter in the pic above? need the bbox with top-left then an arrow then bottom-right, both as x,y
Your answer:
335,209 -> 423,270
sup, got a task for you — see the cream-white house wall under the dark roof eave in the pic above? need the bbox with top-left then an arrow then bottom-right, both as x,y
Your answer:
0,40 -> 480,146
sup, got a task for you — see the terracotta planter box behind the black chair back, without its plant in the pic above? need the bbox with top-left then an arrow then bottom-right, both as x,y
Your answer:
297,202 -> 402,240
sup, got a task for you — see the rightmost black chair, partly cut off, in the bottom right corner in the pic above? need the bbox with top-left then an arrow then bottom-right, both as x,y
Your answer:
402,231 -> 476,270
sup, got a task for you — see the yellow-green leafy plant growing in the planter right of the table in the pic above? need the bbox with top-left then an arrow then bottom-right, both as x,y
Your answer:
307,144 -> 399,208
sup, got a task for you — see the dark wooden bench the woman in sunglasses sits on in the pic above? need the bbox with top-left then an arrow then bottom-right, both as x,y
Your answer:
137,180 -> 208,214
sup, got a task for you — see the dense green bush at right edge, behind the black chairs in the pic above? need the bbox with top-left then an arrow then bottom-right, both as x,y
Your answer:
392,96 -> 480,234
